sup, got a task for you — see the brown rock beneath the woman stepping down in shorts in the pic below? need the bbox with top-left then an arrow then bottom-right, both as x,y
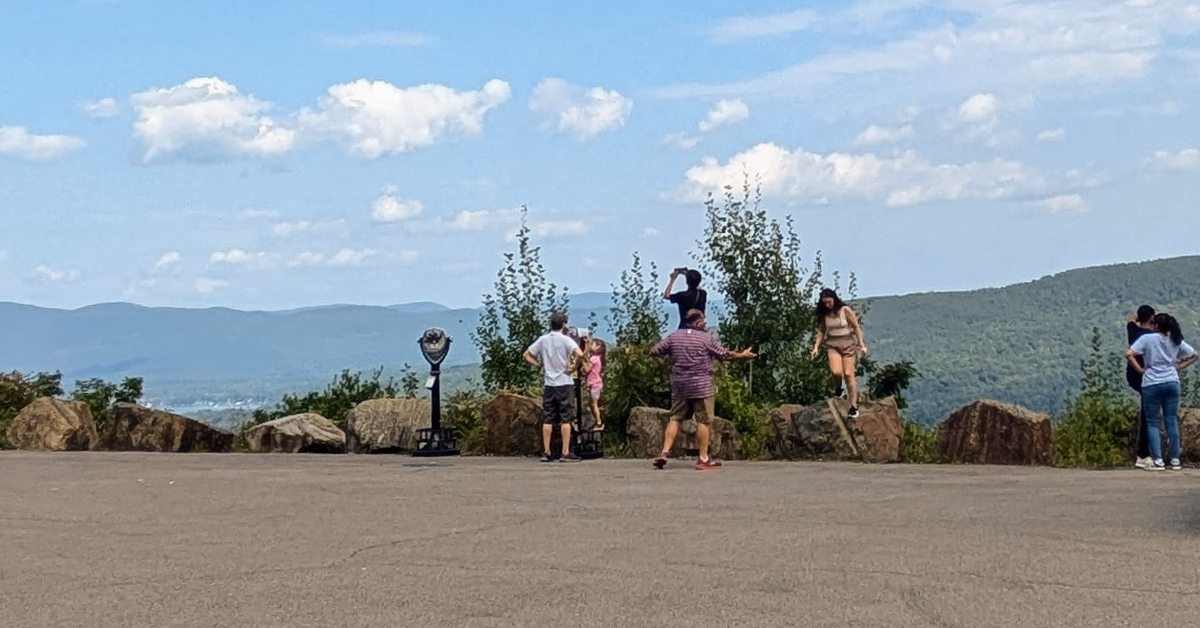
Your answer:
767,397 -> 904,462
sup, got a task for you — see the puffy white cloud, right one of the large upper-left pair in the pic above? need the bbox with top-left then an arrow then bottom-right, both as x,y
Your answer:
298,79 -> 511,159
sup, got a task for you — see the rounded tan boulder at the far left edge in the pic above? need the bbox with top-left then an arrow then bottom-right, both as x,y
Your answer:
6,397 -> 100,451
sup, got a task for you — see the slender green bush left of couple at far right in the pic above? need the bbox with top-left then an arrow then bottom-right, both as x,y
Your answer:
1055,328 -> 1138,467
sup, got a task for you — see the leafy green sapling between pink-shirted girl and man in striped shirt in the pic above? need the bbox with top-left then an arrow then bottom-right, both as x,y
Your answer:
601,253 -> 671,441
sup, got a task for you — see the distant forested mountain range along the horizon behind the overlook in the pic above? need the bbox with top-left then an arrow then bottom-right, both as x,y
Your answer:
0,257 -> 1200,421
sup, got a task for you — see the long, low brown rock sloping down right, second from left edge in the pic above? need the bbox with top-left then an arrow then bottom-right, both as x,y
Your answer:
98,403 -> 233,453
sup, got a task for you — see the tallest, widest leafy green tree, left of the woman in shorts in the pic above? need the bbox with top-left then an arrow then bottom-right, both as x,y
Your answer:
697,183 -> 829,403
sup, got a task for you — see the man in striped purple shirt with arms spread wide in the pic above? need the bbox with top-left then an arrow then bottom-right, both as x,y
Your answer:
650,310 -> 756,471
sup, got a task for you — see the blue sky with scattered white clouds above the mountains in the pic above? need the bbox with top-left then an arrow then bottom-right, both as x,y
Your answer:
0,0 -> 1200,310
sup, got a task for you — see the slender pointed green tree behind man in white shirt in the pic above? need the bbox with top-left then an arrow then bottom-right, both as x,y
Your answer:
470,207 -> 568,393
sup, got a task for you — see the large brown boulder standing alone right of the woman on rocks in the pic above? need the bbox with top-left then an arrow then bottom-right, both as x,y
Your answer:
937,400 -> 1054,465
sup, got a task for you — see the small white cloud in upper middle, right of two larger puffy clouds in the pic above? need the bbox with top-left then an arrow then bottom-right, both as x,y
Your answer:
529,78 -> 634,139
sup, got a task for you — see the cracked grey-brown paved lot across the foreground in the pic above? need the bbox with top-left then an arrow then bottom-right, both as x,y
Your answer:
0,453 -> 1200,628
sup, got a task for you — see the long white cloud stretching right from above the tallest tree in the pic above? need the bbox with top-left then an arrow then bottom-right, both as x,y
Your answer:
668,143 -> 1044,207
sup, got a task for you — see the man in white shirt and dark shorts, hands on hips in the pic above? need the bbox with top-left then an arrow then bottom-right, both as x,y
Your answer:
524,312 -> 583,462
